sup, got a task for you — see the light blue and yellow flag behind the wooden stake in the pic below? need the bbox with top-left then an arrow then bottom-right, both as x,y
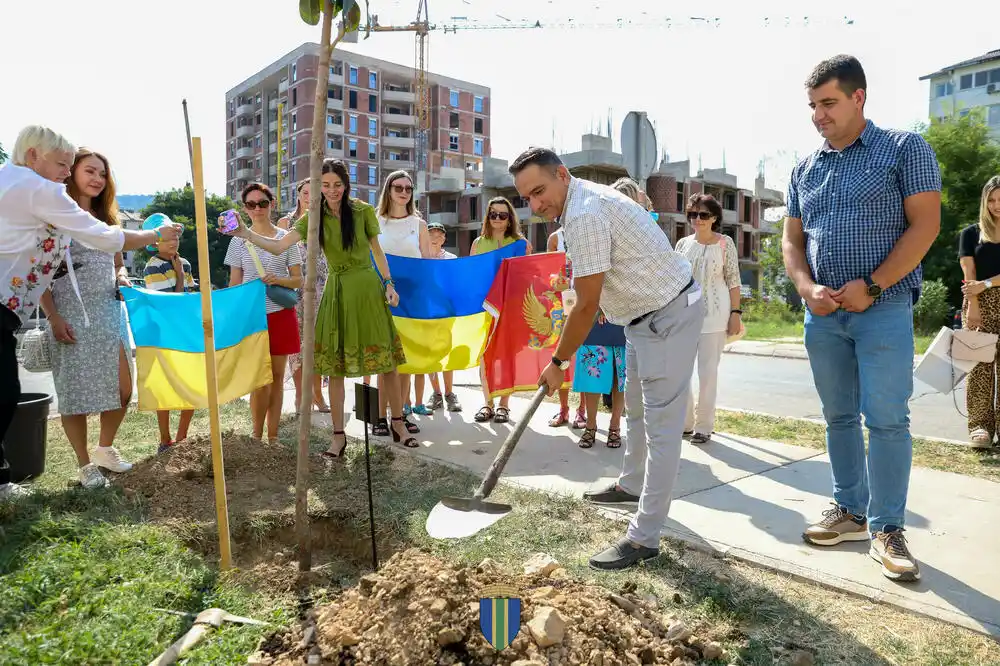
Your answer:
121,280 -> 271,411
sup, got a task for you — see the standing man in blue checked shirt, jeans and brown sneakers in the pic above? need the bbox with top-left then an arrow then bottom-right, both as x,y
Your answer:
783,55 -> 941,581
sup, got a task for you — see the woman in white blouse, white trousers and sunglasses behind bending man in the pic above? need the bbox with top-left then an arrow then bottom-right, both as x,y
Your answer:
677,194 -> 743,444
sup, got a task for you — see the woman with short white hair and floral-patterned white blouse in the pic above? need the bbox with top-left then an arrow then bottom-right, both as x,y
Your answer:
0,125 -> 181,501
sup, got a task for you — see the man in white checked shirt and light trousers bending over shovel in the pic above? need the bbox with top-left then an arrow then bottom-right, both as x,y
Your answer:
510,148 -> 705,569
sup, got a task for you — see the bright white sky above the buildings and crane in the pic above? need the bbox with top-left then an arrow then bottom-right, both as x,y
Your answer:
0,0 -> 1000,194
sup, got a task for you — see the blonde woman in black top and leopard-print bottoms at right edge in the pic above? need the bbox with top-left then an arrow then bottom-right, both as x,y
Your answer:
958,176 -> 1000,449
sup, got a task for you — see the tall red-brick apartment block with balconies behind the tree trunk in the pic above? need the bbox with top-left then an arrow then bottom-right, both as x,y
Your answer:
226,43 -> 490,214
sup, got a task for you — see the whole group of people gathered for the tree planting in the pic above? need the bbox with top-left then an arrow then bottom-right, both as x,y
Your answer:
0,56 -> 1000,581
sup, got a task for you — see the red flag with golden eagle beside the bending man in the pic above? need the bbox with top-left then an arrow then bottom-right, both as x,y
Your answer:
483,252 -> 573,398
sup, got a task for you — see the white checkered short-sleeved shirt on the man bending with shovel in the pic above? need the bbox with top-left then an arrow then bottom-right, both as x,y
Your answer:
559,178 -> 691,326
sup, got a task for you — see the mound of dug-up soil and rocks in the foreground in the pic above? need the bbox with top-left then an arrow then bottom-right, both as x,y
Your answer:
249,549 -> 724,666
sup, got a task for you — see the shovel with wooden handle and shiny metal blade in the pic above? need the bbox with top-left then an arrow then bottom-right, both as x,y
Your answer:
427,386 -> 548,539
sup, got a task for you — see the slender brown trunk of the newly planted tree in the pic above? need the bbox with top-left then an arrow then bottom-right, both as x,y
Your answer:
296,0 -> 346,571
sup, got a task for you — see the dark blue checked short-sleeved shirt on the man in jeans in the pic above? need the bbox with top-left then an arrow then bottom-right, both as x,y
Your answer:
788,120 -> 941,302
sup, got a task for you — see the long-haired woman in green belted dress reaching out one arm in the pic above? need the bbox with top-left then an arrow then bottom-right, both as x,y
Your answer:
219,160 -> 419,458
